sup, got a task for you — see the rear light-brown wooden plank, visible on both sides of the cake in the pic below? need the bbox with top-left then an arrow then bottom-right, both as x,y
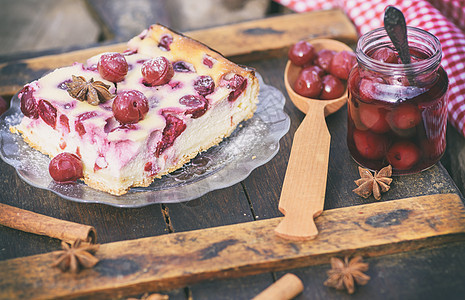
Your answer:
0,10 -> 357,96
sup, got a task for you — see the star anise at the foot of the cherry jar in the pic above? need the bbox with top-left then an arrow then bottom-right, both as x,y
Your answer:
353,165 -> 392,200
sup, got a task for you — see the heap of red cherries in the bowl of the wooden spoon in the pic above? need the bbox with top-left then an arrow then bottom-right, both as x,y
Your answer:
288,41 -> 357,100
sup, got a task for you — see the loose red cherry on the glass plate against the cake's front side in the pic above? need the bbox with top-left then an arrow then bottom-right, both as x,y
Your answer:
48,152 -> 83,183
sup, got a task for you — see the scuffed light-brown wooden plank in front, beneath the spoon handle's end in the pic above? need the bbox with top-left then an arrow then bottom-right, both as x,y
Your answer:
0,194 -> 465,299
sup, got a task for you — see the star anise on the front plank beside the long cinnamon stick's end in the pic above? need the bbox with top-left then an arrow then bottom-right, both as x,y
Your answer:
52,239 -> 99,273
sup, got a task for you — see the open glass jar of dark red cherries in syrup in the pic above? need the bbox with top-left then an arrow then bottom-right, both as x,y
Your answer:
347,27 -> 448,175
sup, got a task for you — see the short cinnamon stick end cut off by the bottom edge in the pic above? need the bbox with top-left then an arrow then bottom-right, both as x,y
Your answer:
252,273 -> 304,300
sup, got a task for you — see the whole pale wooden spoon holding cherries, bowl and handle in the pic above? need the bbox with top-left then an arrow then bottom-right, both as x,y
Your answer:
275,39 -> 352,240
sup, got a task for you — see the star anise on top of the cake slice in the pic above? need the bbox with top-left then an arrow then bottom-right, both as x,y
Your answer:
66,75 -> 113,105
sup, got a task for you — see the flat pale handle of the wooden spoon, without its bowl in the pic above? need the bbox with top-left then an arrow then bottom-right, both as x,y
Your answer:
275,101 -> 331,240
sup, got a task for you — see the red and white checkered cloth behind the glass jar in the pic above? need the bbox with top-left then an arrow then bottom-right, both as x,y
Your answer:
275,0 -> 465,136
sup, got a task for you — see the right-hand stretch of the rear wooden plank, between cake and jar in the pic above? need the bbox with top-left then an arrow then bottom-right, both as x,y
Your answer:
187,10 -> 357,61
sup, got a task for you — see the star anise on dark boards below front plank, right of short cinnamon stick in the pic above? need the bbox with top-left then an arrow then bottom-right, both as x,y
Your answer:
324,256 -> 370,294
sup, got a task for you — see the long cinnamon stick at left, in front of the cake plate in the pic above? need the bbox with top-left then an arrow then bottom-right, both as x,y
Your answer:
0,203 -> 97,243
